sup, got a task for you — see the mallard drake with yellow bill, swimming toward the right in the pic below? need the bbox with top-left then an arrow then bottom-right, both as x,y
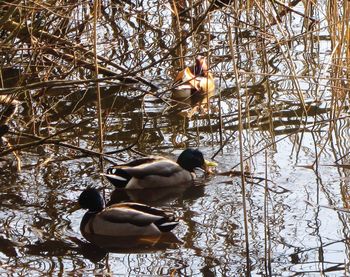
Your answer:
102,148 -> 216,189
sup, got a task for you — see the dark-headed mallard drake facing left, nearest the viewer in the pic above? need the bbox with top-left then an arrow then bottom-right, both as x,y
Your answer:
78,188 -> 178,237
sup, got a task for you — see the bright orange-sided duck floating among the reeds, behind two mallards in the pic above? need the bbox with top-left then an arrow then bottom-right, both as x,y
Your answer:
172,56 -> 215,102
